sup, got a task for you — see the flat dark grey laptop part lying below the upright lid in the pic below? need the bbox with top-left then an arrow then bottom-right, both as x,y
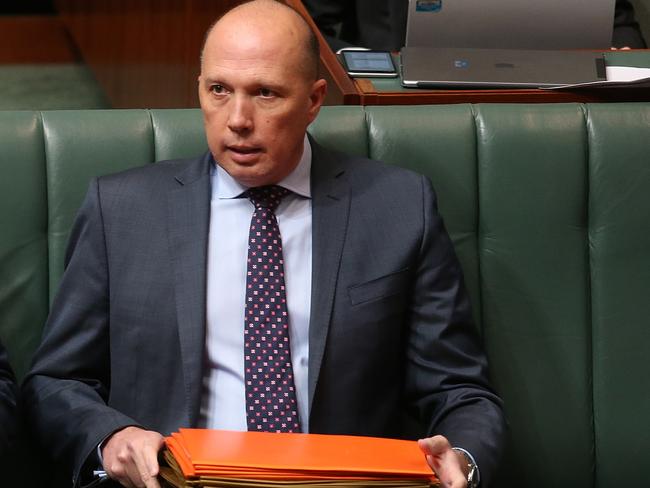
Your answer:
400,47 -> 607,88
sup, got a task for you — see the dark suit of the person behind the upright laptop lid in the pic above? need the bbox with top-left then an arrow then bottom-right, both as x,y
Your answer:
303,0 -> 646,51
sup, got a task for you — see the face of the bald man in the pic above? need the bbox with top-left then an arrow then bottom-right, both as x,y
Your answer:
199,19 -> 326,186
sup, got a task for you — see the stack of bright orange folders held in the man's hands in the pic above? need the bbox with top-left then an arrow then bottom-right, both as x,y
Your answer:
161,429 -> 438,488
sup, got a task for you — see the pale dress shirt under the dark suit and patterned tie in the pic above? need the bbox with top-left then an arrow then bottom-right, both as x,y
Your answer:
199,136 -> 312,432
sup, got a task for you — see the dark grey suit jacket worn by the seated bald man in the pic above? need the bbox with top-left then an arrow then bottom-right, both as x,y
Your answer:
24,143 -> 504,479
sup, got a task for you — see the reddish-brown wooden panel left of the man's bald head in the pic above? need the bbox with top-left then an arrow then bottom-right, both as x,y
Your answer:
56,0 -> 241,108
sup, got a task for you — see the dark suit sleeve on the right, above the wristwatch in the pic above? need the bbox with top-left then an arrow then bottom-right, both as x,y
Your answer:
406,177 -> 505,486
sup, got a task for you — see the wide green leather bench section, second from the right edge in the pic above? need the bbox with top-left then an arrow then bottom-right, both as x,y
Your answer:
477,105 -> 594,487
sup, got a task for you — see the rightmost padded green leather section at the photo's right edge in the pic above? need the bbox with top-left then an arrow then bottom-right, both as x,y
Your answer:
587,104 -> 650,487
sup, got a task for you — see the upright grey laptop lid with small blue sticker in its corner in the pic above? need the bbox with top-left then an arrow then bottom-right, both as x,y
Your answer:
406,0 -> 615,50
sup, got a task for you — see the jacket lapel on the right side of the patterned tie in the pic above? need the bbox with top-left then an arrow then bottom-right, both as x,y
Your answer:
308,140 -> 350,412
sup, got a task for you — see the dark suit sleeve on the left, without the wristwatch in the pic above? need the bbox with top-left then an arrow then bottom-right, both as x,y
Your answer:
23,180 -> 137,483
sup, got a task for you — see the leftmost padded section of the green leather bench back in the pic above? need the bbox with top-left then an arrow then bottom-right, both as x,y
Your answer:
0,112 -> 48,377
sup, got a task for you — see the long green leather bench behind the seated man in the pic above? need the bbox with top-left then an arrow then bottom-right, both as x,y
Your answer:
0,103 -> 650,487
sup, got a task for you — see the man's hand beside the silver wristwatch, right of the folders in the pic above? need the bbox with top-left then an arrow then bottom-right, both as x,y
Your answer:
418,435 -> 467,488
